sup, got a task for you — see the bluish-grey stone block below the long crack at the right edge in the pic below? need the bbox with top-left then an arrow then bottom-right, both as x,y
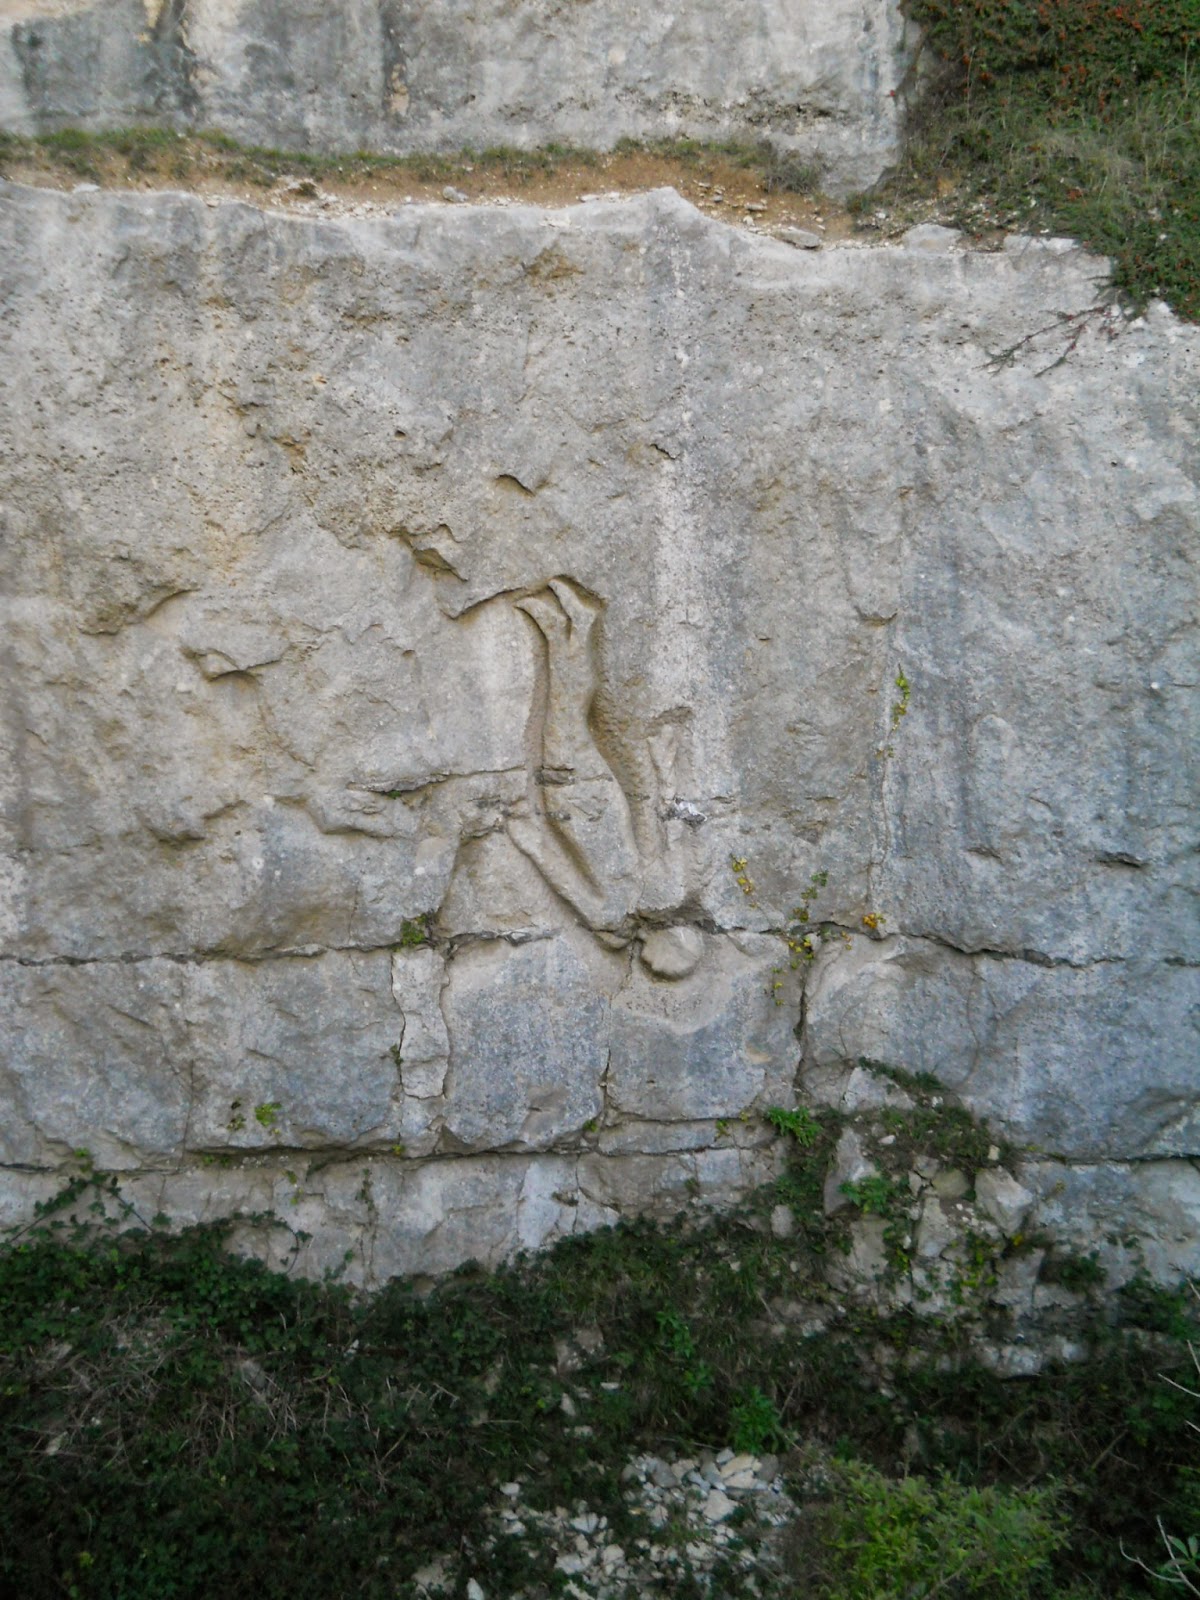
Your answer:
805,934 -> 1200,1160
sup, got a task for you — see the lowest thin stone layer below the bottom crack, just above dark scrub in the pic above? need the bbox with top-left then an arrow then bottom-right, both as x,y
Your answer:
0,1141 -> 1200,1290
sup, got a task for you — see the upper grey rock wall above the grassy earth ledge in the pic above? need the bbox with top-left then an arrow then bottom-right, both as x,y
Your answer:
0,0 -> 909,187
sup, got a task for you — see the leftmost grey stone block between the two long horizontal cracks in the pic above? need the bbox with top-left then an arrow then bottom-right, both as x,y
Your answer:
0,952 -> 400,1168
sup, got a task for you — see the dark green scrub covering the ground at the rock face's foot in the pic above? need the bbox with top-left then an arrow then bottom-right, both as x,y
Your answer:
0,1152 -> 1200,1600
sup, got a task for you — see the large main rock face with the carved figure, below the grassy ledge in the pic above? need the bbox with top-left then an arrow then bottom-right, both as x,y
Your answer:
0,181 -> 1200,1280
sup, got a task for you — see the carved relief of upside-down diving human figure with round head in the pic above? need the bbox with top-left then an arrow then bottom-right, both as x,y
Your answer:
507,578 -> 704,978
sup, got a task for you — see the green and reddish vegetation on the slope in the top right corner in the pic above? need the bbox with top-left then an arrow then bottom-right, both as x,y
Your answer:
902,0 -> 1200,320
